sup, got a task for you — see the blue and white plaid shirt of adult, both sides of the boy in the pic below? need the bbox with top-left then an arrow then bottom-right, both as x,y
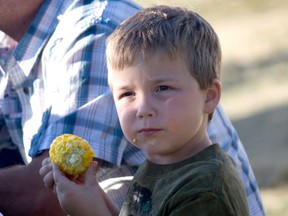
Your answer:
0,0 -> 264,216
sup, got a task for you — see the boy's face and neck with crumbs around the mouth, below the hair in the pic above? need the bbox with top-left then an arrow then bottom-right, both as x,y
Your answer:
109,55 -> 215,164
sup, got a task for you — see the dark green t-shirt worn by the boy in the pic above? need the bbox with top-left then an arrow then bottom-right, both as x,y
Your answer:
120,144 -> 249,216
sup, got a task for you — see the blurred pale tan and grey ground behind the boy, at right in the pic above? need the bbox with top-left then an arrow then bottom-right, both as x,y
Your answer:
136,0 -> 288,216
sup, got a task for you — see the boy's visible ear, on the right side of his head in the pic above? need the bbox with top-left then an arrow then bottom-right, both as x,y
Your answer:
204,80 -> 221,113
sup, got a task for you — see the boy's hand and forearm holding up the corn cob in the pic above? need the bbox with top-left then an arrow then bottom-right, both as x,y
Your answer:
39,158 -> 119,216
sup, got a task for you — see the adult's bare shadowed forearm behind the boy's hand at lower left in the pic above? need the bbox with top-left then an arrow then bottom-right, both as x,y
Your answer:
0,151 -> 65,216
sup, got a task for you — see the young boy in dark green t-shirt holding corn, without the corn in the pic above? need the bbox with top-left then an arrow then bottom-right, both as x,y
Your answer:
40,6 -> 249,216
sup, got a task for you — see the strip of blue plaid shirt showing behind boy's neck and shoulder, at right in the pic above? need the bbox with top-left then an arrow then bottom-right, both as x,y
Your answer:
208,105 -> 265,216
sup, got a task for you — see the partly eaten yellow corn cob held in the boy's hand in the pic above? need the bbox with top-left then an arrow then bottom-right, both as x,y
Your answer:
49,134 -> 94,176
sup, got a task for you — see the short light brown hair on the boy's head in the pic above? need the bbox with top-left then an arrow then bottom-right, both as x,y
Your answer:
106,6 -> 221,89
